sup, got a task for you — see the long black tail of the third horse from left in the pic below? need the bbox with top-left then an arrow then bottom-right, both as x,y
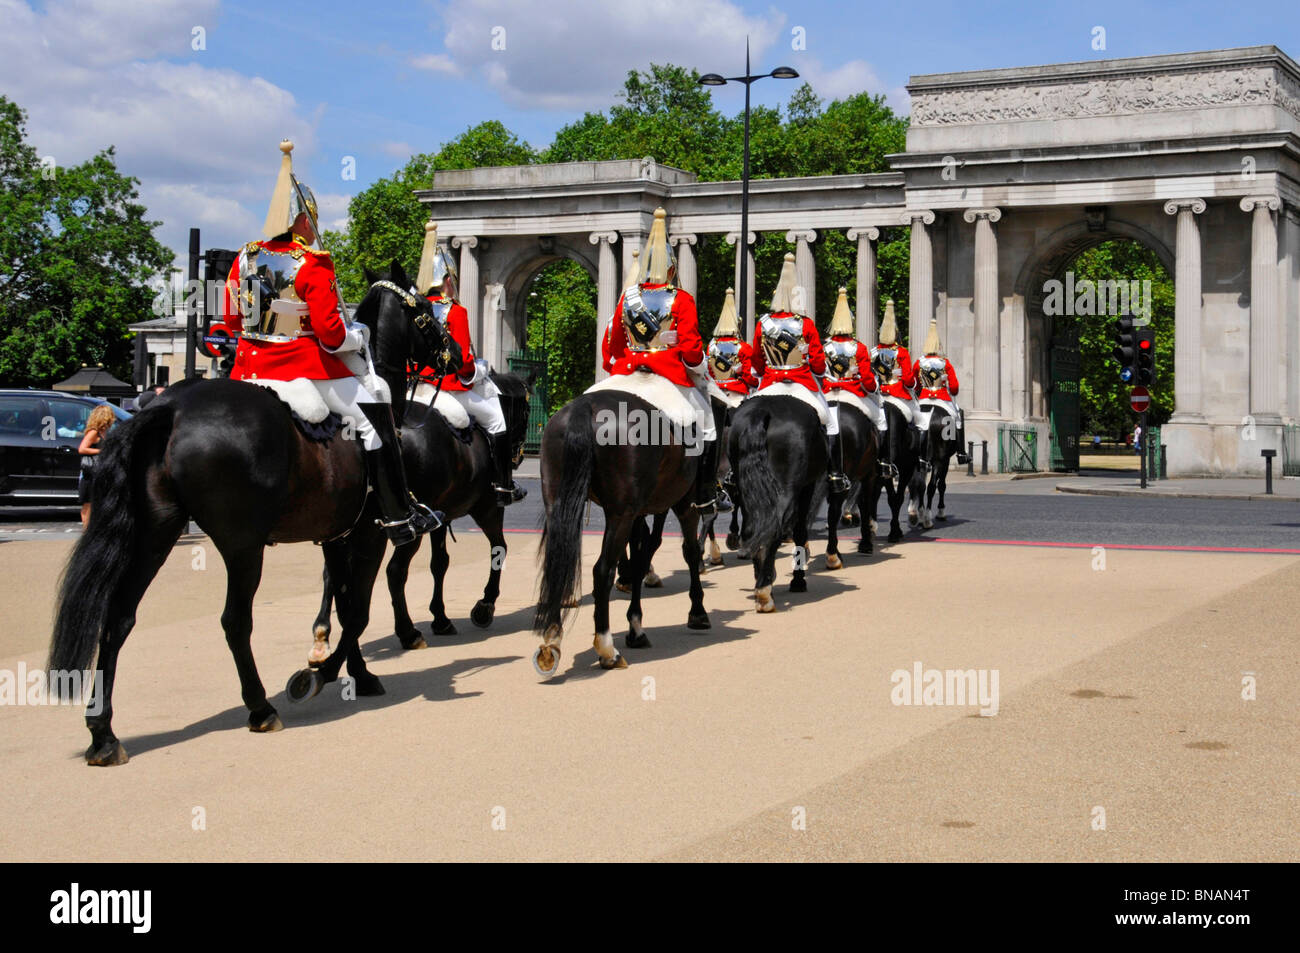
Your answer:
533,406 -> 595,634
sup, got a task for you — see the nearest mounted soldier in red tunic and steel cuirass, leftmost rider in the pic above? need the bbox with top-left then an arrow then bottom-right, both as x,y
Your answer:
222,139 -> 441,546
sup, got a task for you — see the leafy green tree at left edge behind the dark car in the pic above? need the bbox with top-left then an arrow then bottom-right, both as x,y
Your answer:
0,96 -> 173,386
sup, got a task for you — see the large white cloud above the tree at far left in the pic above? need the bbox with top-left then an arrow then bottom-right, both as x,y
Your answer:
0,0 -> 315,257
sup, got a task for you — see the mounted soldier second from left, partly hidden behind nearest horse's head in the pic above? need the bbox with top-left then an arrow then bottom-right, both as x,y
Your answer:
415,221 -> 528,507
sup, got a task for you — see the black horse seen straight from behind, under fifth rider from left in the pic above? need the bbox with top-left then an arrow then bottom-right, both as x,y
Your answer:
728,395 -> 827,612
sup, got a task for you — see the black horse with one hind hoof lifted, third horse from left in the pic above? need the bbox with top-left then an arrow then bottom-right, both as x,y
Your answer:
533,390 -> 710,677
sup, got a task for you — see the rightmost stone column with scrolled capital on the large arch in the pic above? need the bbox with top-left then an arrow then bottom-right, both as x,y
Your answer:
1242,195 -> 1282,424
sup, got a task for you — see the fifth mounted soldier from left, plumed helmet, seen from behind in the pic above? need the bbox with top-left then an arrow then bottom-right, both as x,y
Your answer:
753,252 -> 849,493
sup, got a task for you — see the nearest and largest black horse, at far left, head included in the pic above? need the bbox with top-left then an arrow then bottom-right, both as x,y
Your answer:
48,267 -> 460,764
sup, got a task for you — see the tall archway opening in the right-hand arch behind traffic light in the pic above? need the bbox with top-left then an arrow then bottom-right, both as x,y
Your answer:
1043,237 -> 1174,472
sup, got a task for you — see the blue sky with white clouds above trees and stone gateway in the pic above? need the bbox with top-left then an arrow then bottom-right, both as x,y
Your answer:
0,0 -> 1300,267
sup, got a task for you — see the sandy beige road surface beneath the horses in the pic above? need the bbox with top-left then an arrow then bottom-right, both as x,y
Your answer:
0,534 -> 1300,861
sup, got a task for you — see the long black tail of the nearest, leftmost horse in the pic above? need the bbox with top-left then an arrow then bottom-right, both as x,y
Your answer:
47,402 -> 176,672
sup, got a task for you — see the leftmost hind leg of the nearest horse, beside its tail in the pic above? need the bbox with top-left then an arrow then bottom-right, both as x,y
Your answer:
82,519 -> 185,767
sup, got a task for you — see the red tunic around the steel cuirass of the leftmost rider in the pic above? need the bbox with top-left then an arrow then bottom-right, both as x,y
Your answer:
221,242 -> 352,381
